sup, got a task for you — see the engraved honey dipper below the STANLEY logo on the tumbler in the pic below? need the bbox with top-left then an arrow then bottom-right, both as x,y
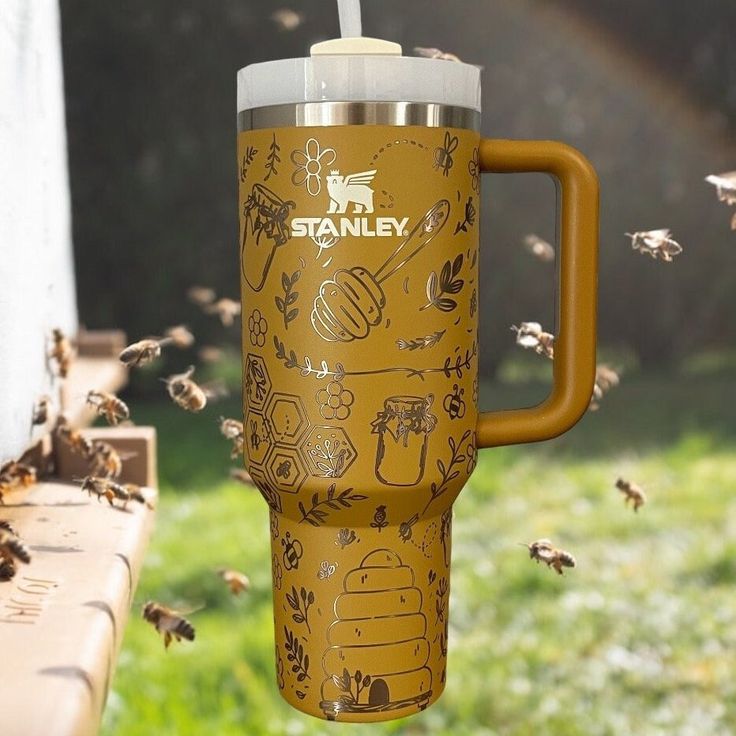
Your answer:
311,199 -> 450,342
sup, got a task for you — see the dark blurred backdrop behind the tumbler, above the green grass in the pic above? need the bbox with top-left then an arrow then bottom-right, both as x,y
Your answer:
62,0 -> 736,375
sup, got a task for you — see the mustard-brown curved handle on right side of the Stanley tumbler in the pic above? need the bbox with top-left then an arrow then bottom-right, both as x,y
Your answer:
476,139 -> 598,447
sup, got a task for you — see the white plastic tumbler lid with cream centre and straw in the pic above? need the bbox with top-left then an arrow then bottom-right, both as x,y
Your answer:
238,0 -> 480,112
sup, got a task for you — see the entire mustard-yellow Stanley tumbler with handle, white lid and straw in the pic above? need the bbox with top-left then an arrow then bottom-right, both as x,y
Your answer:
237,0 -> 598,722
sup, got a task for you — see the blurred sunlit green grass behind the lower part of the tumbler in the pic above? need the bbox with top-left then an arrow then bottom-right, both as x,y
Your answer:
103,374 -> 736,736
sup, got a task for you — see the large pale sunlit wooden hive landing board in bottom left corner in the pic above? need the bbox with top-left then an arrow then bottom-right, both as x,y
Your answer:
0,482 -> 156,736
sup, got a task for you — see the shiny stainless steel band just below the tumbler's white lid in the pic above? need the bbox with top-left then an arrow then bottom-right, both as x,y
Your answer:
238,102 -> 480,133
